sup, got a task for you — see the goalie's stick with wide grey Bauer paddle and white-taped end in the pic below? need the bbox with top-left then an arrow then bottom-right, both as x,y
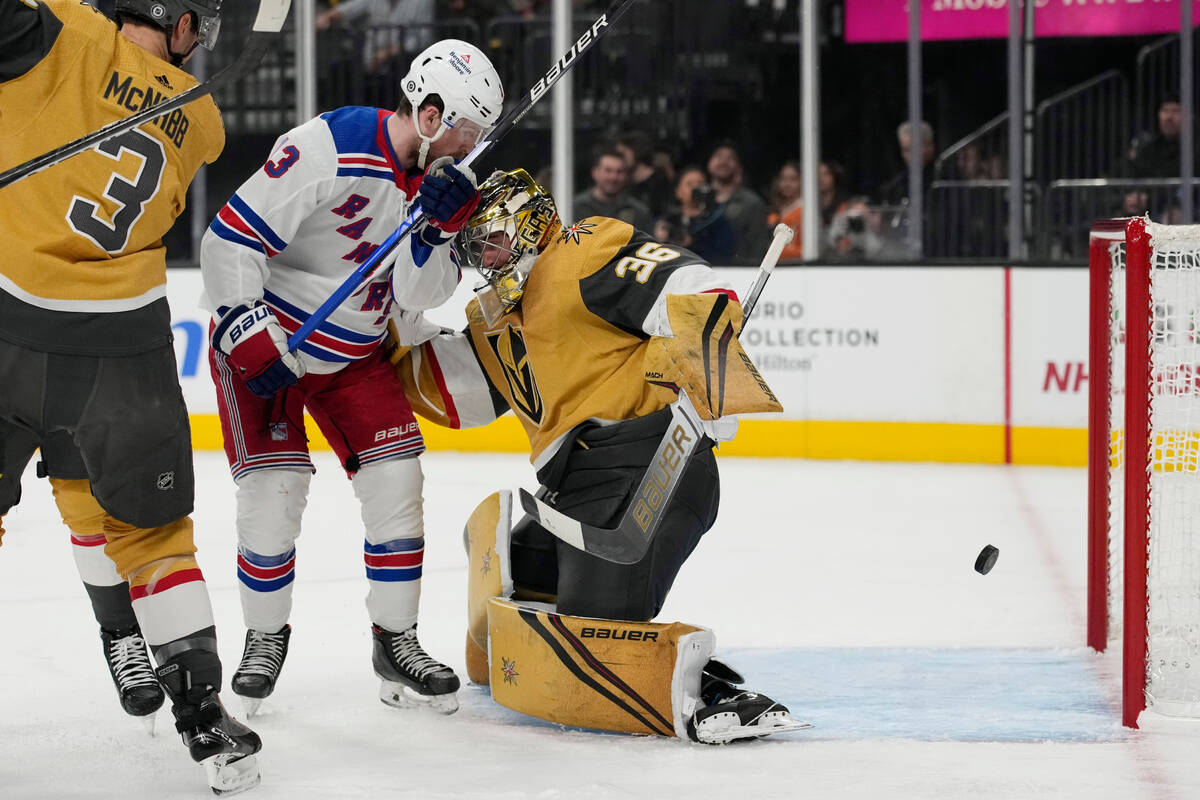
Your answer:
520,223 -> 793,564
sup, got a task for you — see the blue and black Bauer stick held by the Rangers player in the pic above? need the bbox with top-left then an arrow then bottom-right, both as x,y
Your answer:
288,0 -> 637,351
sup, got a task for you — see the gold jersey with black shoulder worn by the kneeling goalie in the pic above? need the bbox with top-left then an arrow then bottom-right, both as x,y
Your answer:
397,217 -> 733,468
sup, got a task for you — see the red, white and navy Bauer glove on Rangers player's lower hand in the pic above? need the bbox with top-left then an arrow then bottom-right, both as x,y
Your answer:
212,303 -> 305,397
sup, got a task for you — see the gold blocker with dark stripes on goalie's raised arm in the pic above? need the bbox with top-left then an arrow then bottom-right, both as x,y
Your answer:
644,294 -> 784,420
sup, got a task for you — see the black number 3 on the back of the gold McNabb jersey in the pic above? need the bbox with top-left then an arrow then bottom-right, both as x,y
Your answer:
67,128 -> 167,254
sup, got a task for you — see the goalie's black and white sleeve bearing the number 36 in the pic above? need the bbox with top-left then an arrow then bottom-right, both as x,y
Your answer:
580,230 -> 737,338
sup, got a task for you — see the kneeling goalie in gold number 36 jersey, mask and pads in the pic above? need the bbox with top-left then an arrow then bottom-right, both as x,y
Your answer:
394,169 -> 806,742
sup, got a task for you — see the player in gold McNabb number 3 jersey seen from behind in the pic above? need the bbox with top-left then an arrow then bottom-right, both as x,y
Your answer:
0,0 -> 260,790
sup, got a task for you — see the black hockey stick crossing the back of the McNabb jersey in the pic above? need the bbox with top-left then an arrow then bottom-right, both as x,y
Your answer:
0,0 -> 292,188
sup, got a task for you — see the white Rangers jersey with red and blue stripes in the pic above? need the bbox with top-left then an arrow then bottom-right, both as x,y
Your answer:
200,107 -> 462,373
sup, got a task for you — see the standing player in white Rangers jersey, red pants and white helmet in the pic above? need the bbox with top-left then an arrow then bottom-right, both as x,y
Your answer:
200,40 -> 504,714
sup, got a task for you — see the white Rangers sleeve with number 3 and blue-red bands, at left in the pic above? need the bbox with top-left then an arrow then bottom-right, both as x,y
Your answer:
200,118 -> 337,312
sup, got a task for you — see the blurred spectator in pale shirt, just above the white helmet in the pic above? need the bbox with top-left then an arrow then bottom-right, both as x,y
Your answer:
317,0 -> 434,79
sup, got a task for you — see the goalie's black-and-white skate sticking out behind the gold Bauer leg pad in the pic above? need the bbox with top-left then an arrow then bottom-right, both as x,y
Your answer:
688,658 -> 812,745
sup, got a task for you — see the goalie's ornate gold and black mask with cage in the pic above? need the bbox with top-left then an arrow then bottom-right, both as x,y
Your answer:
457,169 -> 562,324
